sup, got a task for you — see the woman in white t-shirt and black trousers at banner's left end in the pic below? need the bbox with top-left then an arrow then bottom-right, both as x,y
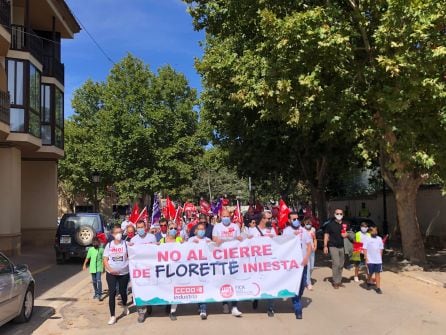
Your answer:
103,225 -> 130,325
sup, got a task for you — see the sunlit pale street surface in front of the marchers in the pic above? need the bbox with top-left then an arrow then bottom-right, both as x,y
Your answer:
0,254 -> 446,335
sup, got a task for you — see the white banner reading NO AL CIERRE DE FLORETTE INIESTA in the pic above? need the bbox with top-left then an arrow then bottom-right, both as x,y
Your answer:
128,236 -> 303,306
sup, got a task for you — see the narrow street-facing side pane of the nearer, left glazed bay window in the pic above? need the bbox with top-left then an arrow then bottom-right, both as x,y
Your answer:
28,63 -> 40,137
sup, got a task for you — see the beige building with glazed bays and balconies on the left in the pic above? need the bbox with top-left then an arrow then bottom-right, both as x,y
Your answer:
0,0 -> 80,254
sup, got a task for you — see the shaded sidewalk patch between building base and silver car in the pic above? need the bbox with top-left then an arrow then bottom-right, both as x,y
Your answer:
10,246 -> 56,275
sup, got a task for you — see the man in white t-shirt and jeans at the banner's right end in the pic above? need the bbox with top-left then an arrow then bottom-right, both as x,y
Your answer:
282,212 -> 313,320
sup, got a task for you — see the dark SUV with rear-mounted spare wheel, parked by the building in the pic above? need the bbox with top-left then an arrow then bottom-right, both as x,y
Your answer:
54,213 -> 108,264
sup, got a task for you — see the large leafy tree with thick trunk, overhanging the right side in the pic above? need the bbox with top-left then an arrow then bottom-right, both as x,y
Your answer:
186,0 -> 446,262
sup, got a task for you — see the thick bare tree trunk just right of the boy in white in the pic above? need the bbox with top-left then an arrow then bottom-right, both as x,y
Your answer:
394,178 -> 426,264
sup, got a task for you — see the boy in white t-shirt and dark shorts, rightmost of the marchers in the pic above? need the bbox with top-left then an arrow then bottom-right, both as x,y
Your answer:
363,227 -> 384,294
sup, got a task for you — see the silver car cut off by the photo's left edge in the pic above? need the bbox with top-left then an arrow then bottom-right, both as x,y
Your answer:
0,252 -> 35,326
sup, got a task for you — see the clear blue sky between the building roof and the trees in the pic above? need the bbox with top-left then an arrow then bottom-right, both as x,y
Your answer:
62,0 -> 204,117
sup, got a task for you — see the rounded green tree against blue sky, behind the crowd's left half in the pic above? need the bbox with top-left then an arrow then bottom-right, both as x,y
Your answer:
60,54 -> 203,203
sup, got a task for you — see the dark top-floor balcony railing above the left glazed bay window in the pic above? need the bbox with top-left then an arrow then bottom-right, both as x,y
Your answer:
11,24 -> 43,63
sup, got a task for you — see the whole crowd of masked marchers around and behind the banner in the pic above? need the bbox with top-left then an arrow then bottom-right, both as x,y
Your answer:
83,202 -> 383,325
